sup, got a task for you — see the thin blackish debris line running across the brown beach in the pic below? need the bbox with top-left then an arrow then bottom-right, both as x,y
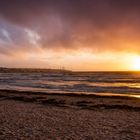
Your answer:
0,93 -> 140,111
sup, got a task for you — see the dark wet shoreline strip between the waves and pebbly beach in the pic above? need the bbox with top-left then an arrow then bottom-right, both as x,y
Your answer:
0,90 -> 140,111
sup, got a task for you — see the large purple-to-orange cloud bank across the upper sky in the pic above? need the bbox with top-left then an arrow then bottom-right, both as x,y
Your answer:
0,0 -> 140,50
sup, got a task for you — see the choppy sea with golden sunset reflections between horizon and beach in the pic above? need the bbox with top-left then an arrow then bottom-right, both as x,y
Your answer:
0,72 -> 140,98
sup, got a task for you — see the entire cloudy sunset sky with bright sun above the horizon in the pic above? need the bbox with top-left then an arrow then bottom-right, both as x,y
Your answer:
0,0 -> 140,71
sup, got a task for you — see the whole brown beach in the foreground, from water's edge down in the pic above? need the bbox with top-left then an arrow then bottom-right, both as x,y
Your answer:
0,91 -> 140,140
